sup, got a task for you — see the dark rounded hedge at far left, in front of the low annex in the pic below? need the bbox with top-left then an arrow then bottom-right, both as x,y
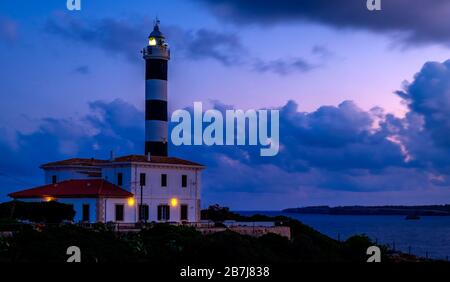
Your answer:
0,201 -> 75,223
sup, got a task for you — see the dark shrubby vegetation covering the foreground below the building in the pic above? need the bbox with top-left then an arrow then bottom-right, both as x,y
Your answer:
0,206 -> 390,265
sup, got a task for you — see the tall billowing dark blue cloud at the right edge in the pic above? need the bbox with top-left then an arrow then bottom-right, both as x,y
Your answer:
387,61 -> 450,176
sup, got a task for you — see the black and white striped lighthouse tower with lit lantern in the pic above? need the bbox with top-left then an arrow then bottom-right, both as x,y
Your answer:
142,20 -> 170,156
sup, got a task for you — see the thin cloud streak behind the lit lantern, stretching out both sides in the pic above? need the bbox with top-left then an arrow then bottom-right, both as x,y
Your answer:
45,13 -> 317,75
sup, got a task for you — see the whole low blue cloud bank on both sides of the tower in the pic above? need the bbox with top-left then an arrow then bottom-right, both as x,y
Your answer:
0,61 -> 450,203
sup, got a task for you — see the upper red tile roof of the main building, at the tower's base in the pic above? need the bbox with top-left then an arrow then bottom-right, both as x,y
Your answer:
41,155 -> 203,168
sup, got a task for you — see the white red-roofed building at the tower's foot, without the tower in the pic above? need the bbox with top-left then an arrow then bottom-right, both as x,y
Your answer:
9,155 -> 204,223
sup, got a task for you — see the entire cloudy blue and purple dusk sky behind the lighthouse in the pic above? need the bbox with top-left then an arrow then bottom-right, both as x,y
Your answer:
0,0 -> 450,209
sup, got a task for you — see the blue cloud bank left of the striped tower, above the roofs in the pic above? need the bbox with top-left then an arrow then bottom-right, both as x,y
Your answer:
0,100 -> 144,198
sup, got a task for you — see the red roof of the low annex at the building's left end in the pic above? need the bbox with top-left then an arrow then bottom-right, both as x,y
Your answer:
8,179 -> 133,199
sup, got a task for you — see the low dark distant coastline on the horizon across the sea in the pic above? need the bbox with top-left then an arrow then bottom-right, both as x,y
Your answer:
282,205 -> 450,216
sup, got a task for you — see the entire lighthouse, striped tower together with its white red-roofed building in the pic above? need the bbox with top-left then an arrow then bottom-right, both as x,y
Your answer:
9,21 -> 204,223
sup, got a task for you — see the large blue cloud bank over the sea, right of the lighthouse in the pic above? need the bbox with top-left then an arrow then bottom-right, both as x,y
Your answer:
170,59 -> 450,196
